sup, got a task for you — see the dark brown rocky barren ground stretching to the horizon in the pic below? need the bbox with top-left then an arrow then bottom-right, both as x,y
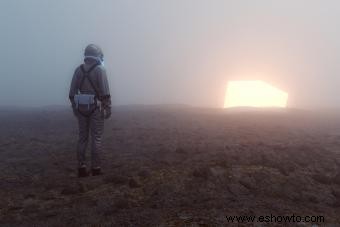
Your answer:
0,106 -> 340,226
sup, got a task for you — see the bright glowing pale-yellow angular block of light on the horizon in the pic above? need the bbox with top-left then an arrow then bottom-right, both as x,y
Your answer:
224,80 -> 288,108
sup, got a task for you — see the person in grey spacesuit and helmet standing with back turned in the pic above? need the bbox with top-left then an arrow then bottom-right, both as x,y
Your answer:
69,44 -> 111,177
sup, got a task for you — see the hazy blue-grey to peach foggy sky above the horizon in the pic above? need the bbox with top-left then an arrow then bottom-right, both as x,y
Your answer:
0,0 -> 340,108
